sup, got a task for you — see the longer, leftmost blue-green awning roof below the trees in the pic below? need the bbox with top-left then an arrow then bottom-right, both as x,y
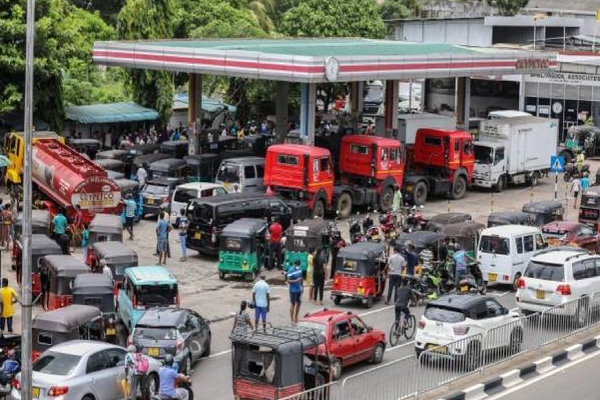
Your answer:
66,102 -> 158,124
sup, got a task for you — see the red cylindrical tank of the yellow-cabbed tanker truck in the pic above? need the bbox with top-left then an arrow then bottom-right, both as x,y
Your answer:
32,139 -> 122,222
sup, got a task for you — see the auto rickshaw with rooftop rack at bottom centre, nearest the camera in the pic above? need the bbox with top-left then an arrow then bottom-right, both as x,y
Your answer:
229,326 -> 333,400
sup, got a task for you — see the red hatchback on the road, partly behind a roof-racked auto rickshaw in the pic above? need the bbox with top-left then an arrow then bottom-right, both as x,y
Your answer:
299,309 -> 386,380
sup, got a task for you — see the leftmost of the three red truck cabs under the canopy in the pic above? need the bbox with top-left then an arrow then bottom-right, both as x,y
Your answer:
264,144 -> 334,217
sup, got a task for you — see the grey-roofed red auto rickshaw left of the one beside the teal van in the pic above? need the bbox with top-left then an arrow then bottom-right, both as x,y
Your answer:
40,254 -> 92,310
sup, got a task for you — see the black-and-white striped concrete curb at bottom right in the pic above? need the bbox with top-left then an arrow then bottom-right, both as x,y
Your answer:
439,336 -> 600,400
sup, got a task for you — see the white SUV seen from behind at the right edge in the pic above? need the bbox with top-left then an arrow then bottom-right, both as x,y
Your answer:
516,247 -> 600,324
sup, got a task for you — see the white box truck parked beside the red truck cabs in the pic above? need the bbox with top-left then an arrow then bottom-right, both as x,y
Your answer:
473,116 -> 558,192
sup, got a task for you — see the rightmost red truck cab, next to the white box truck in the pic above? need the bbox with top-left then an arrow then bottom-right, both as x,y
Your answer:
404,128 -> 475,205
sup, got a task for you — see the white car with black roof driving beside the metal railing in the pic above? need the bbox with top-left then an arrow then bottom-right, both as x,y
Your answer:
415,293 -> 523,368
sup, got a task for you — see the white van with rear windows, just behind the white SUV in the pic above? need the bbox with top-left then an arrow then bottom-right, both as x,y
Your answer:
477,225 -> 546,288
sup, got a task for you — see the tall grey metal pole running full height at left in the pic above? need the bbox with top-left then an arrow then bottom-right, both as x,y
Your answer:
21,0 -> 35,400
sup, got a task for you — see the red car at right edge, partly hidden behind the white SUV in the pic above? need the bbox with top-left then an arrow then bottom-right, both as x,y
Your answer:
542,221 -> 598,251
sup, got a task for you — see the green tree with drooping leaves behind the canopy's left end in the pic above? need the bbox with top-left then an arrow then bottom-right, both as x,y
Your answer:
117,0 -> 176,126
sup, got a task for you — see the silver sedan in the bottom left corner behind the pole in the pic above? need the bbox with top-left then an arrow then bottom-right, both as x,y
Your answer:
11,340 -> 160,400
